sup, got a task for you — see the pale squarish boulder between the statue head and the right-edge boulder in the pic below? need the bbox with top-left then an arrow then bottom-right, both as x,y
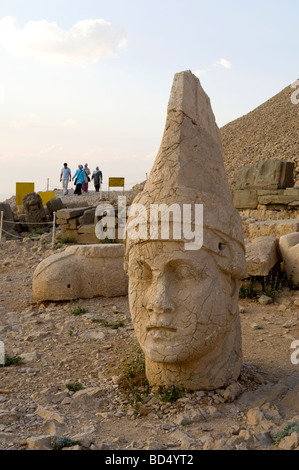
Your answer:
246,237 -> 281,276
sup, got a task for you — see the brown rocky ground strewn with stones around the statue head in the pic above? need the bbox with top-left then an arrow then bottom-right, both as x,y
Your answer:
0,234 -> 299,450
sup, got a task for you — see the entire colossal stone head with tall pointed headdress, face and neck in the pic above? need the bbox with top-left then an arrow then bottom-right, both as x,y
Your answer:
125,71 -> 246,390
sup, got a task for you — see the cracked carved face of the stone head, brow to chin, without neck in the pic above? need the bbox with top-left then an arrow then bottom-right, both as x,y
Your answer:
128,241 -> 236,363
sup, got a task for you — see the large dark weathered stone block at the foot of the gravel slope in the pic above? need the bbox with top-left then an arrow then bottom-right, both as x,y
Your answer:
233,159 -> 295,189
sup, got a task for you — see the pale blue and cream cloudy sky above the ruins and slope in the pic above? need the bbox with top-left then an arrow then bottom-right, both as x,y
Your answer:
0,0 -> 299,201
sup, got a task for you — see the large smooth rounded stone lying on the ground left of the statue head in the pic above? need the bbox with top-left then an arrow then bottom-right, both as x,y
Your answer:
32,244 -> 128,301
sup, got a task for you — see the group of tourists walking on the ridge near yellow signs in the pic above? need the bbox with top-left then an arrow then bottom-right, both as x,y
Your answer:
60,163 -> 103,196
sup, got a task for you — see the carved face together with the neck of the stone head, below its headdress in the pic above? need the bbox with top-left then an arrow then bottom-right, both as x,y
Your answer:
128,241 -> 241,390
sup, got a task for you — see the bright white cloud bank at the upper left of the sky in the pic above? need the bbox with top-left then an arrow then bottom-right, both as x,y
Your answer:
0,16 -> 126,64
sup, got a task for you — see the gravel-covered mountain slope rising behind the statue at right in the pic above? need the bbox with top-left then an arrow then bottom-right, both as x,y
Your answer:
220,81 -> 299,184
